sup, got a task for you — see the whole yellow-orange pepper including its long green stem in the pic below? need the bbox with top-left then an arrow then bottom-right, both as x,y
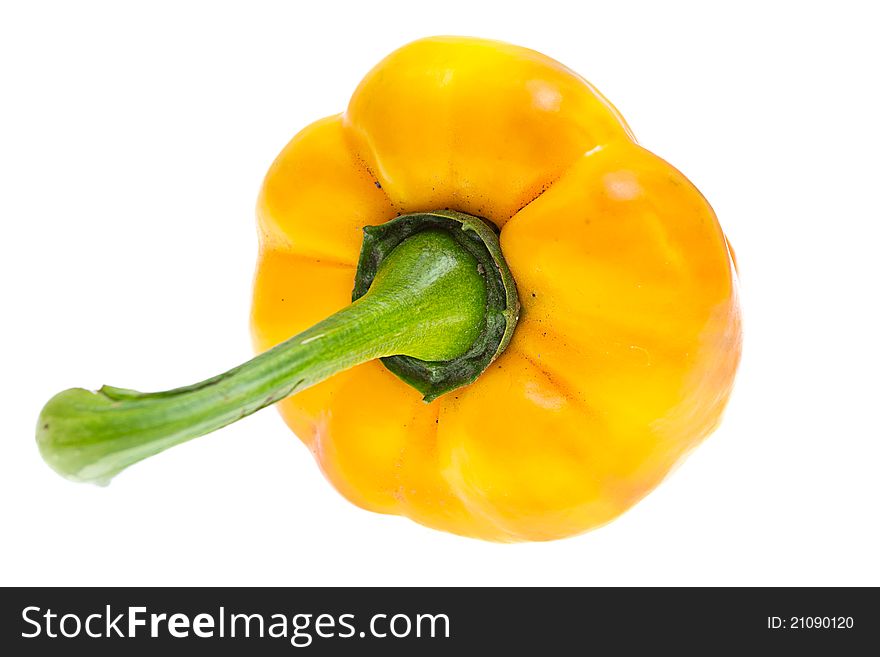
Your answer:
37,37 -> 742,541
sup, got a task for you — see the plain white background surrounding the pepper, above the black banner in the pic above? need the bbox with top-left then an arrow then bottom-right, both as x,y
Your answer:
0,0 -> 880,585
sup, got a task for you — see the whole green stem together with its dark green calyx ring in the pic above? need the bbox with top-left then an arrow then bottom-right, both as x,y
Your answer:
36,211 -> 519,484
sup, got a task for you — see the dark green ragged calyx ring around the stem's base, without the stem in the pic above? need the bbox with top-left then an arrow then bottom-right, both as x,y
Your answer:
352,210 -> 520,402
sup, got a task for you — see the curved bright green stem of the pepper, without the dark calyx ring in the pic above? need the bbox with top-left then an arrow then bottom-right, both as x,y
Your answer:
37,229 -> 486,483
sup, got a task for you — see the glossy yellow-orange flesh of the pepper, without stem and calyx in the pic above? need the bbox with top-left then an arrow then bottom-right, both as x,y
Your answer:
252,38 -> 741,541
